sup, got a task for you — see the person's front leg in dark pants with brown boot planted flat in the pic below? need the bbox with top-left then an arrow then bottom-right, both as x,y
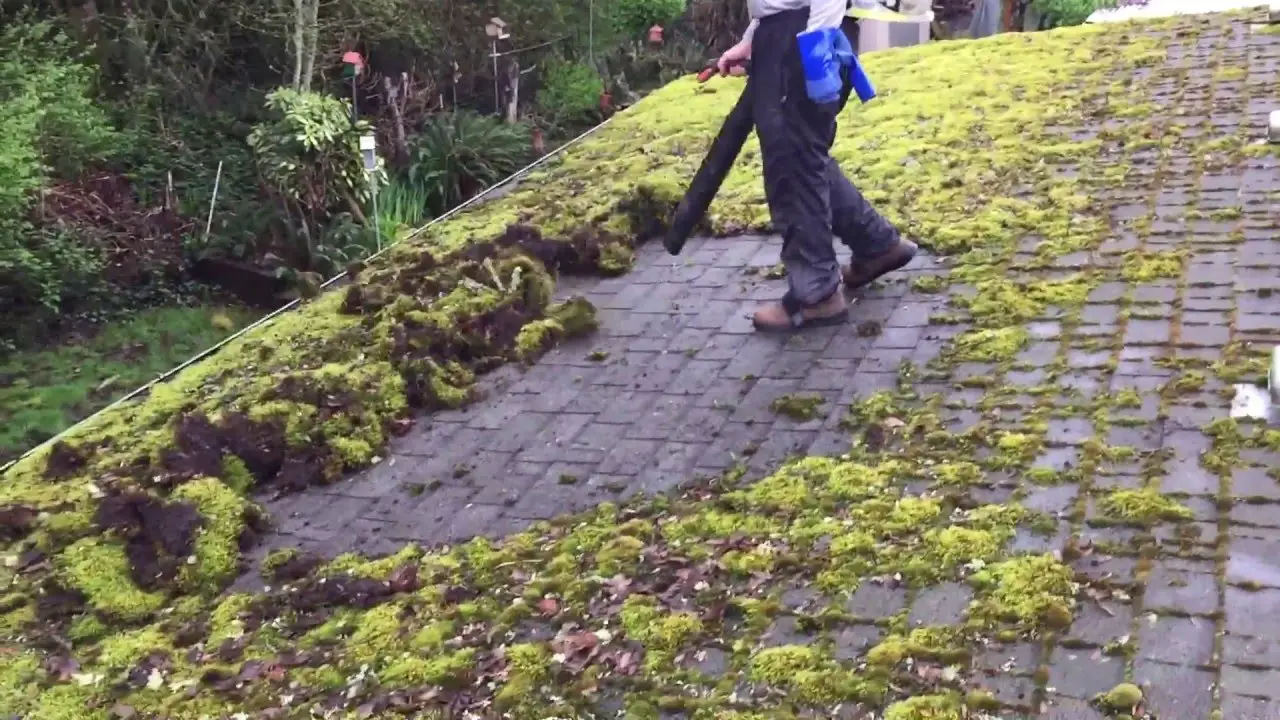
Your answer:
750,10 -> 849,331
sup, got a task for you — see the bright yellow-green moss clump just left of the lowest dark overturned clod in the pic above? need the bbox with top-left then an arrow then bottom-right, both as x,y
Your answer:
55,538 -> 165,623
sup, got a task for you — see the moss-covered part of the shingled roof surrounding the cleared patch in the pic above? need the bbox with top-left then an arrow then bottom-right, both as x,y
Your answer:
0,10 -> 1280,720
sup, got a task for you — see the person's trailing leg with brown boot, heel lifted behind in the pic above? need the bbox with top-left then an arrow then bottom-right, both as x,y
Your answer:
827,159 -> 916,290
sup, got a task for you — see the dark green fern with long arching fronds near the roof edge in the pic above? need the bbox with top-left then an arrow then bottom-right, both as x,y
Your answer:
407,110 -> 531,215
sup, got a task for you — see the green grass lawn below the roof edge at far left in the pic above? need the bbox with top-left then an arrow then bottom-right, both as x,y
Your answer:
0,301 -> 256,462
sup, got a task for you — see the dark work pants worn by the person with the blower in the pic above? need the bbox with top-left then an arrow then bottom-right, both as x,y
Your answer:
748,9 -> 897,306
